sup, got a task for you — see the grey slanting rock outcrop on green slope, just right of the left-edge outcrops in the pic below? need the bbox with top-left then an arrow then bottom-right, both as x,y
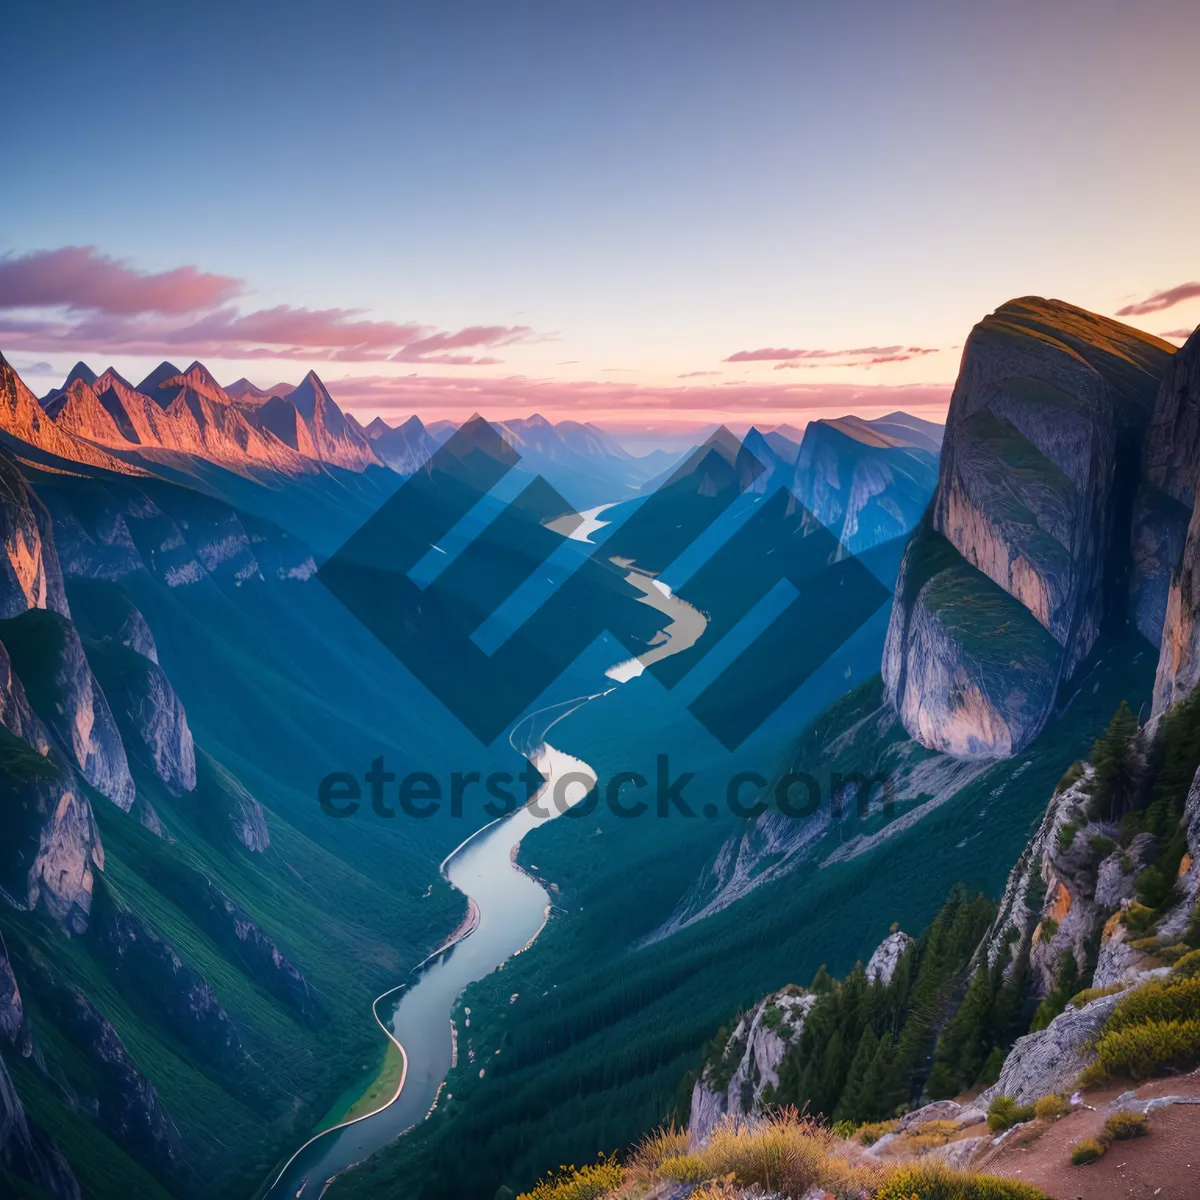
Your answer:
88,638 -> 196,793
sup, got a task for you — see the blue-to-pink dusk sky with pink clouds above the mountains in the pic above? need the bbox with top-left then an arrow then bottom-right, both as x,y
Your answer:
0,0 -> 1200,426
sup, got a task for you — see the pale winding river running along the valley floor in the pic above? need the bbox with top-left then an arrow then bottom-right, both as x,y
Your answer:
263,509 -> 706,1200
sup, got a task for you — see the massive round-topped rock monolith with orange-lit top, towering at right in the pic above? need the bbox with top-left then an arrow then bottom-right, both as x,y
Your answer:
883,299 -> 1172,757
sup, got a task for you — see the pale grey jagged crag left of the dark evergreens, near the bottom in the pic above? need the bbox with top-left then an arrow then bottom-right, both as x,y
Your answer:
688,988 -> 817,1147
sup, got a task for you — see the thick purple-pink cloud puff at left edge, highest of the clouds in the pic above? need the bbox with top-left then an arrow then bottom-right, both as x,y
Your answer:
0,246 -> 242,316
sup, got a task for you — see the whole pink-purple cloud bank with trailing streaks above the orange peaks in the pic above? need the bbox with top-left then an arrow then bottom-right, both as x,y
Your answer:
0,246 -> 535,366
